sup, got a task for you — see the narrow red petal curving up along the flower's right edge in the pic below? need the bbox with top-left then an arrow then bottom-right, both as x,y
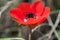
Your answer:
35,7 -> 50,24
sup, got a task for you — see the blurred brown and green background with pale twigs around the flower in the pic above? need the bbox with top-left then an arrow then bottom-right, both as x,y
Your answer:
0,0 -> 60,40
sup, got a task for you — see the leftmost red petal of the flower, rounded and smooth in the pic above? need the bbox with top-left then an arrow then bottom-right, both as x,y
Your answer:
10,8 -> 24,19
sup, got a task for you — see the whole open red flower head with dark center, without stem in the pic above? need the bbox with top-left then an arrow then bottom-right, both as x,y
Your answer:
10,1 -> 50,25
